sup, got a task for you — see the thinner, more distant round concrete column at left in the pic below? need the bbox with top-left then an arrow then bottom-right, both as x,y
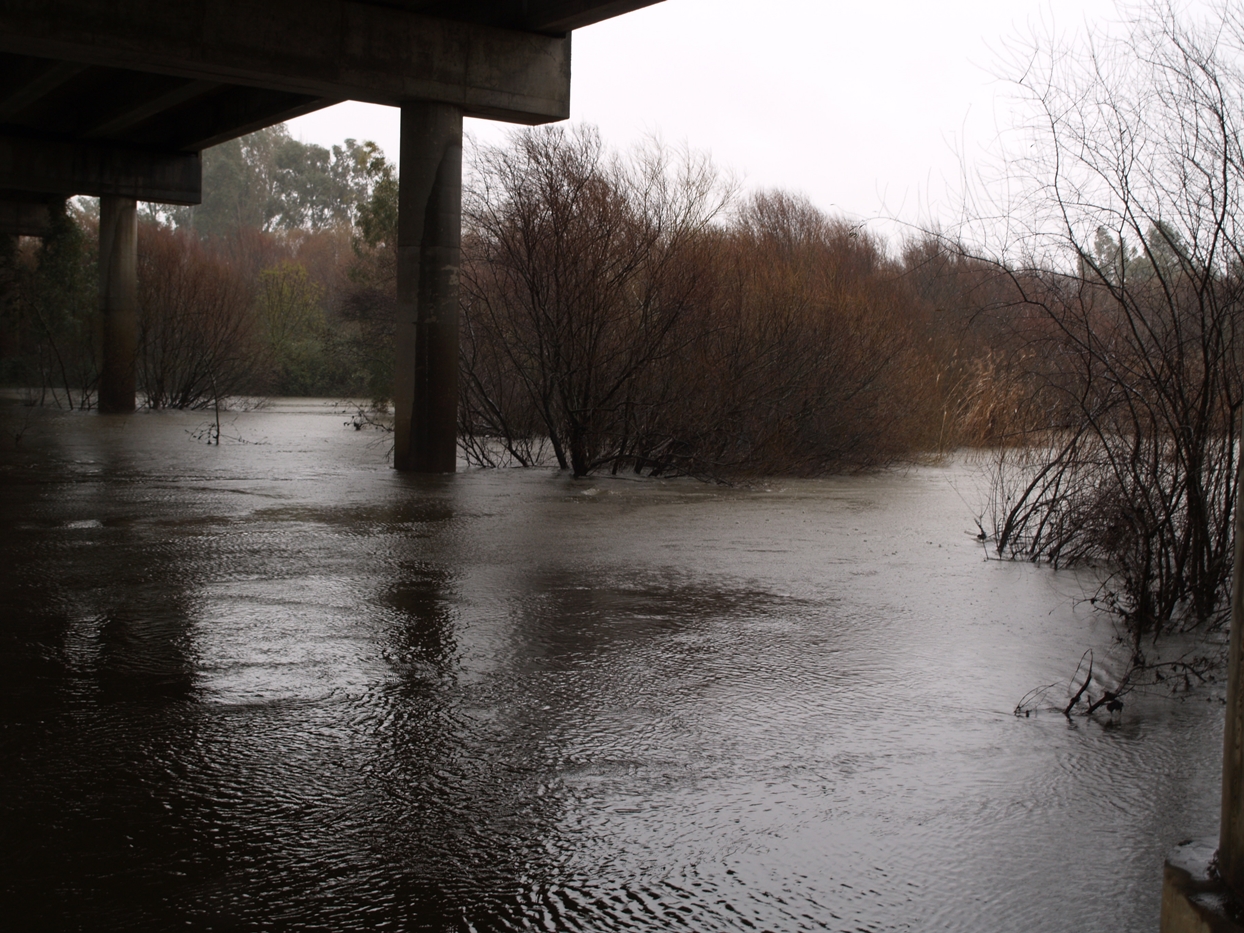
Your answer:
100,195 -> 138,413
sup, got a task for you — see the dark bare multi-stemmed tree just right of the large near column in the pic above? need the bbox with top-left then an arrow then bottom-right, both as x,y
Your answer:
462,127 -> 729,475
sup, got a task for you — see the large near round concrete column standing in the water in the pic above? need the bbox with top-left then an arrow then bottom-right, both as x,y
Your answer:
393,101 -> 463,473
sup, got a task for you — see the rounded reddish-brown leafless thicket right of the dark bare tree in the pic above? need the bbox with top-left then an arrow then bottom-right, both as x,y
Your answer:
648,193 -> 935,475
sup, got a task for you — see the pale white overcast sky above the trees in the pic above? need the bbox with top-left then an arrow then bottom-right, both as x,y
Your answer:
290,0 -> 1139,237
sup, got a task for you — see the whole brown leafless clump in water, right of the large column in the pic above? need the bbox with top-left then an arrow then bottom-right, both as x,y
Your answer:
460,128 -> 938,478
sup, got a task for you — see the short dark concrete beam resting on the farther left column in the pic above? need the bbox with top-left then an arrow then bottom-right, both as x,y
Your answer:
0,134 -> 203,204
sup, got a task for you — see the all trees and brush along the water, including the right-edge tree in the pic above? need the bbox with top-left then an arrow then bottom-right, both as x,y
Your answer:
0,0 -> 1244,658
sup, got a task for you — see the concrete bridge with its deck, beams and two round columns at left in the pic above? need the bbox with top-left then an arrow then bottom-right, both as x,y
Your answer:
0,0 -> 659,473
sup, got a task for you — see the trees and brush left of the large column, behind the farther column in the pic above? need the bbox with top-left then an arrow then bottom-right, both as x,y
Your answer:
0,126 -> 396,408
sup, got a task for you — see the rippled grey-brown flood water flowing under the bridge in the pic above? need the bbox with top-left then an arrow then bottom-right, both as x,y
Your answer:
0,402 -> 1223,933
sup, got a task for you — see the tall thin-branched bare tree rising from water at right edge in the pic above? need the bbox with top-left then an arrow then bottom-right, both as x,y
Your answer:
975,1 -> 1244,661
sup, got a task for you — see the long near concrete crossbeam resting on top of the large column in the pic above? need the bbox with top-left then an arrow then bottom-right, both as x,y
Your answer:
0,0 -> 570,124
